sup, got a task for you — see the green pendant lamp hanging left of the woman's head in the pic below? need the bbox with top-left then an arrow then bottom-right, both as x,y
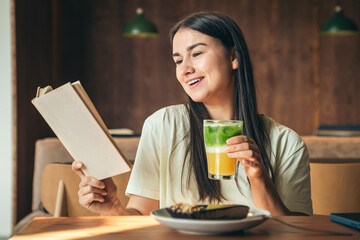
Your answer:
122,8 -> 158,37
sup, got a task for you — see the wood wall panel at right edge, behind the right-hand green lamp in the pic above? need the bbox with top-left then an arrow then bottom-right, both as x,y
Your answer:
319,0 -> 360,125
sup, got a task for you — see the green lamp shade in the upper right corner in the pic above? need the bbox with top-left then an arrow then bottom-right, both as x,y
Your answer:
320,6 -> 358,35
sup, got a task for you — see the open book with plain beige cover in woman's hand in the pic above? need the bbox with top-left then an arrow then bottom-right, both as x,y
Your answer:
31,81 -> 131,180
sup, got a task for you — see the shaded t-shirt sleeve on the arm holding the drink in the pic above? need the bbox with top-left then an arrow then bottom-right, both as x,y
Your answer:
275,135 -> 313,215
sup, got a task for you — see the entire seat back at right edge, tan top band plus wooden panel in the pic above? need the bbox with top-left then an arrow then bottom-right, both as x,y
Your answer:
302,136 -> 360,215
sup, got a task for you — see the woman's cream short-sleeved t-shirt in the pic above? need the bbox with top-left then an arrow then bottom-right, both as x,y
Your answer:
126,105 -> 312,215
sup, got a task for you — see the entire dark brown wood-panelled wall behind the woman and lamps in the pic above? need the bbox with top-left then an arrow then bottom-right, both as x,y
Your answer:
15,0 -> 360,220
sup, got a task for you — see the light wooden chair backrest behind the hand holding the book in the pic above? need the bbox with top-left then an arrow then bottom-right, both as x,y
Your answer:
41,164 -> 130,217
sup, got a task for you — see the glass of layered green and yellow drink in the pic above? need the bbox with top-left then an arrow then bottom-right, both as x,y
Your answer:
204,120 -> 243,180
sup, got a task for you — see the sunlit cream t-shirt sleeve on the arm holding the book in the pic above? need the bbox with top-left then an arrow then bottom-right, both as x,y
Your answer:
125,115 -> 160,200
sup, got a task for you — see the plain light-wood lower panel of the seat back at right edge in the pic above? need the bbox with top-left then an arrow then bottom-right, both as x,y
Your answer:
310,163 -> 360,215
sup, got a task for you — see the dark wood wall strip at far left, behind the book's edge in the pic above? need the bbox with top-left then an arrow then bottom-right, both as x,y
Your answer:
14,0 -> 52,221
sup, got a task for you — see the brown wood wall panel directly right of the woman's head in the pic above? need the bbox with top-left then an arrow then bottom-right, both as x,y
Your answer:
184,0 -> 313,134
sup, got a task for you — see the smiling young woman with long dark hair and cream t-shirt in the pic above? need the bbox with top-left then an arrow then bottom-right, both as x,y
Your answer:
73,13 -> 312,216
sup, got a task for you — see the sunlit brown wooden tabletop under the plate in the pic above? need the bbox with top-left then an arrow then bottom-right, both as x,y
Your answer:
10,216 -> 360,240
